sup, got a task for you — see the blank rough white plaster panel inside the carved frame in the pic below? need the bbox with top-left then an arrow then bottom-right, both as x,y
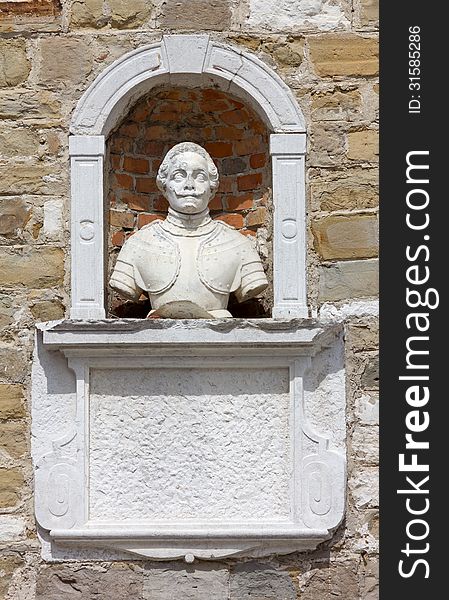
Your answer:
90,368 -> 292,521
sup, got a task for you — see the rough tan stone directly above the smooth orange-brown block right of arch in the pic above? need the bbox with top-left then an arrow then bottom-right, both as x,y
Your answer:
310,168 -> 379,211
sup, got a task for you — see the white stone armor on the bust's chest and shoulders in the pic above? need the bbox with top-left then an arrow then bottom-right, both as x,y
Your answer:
110,211 -> 268,317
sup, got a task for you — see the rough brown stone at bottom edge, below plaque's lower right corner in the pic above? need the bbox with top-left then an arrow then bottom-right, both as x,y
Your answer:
300,561 -> 360,600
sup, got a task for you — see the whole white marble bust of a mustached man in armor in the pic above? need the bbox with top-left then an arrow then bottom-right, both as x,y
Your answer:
109,142 -> 268,318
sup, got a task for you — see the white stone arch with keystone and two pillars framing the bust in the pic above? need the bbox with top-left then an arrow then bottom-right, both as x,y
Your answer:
69,35 -> 308,319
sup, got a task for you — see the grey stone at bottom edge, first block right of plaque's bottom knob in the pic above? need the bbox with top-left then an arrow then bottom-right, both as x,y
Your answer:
230,562 -> 296,600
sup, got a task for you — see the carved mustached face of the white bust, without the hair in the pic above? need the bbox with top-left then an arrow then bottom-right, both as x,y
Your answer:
165,152 -> 212,215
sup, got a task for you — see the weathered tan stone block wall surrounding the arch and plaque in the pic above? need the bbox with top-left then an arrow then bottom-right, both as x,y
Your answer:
0,0 -> 378,600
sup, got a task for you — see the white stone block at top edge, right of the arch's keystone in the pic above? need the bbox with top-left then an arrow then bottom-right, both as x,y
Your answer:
247,0 -> 350,31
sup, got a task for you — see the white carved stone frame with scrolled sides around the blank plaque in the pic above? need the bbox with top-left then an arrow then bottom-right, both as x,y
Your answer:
35,320 -> 346,562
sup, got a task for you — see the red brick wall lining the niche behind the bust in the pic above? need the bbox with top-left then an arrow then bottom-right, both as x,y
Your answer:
108,89 -> 272,317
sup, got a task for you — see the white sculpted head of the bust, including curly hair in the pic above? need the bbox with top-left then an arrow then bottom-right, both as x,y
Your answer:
156,142 -> 218,215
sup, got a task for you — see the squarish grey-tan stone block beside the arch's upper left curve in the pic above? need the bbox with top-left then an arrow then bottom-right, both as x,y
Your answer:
39,37 -> 92,89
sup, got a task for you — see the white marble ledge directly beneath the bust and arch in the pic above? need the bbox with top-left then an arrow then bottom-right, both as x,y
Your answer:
37,319 -> 342,356
